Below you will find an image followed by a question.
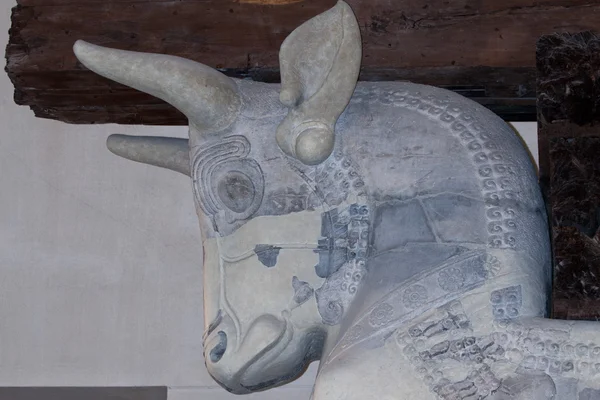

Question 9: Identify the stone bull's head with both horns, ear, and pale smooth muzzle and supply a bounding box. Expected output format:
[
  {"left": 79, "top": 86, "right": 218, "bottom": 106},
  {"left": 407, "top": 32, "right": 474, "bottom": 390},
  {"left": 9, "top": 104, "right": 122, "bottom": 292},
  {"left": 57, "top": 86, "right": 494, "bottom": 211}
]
[{"left": 74, "top": 1, "right": 361, "bottom": 393}]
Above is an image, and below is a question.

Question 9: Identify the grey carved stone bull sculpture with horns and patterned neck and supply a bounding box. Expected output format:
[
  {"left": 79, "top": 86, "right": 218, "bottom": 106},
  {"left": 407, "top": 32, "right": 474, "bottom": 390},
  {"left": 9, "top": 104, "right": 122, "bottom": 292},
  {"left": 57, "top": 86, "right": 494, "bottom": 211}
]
[{"left": 74, "top": 2, "right": 600, "bottom": 400}]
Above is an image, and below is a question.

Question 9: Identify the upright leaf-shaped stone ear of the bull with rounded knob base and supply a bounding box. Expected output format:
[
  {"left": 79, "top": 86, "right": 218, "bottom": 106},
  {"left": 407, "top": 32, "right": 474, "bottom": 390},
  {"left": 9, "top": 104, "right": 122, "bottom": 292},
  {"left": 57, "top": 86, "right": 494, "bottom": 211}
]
[{"left": 277, "top": 1, "right": 362, "bottom": 165}]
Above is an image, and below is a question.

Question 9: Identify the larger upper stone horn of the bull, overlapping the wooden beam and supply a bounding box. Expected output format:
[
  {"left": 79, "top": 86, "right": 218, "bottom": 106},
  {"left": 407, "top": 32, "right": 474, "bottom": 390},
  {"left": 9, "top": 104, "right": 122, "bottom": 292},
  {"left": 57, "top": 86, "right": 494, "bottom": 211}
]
[{"left": 73, "top": 40, "right": 242, "bottom": 133}]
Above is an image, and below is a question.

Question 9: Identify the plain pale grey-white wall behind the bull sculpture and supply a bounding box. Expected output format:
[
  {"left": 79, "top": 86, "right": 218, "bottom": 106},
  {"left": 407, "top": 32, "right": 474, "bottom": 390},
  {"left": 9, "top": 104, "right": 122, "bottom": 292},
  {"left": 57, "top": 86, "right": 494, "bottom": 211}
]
[{"left": 0, "top": 0, "right": 537, "bottom": 400}]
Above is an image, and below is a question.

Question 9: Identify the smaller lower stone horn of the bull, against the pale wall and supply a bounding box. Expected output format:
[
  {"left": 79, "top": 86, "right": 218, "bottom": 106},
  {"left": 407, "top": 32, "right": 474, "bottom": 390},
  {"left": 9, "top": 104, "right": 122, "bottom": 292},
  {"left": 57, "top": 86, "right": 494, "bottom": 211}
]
[{"left": 106, "top": 135, "right": 190, "bottom": 176}]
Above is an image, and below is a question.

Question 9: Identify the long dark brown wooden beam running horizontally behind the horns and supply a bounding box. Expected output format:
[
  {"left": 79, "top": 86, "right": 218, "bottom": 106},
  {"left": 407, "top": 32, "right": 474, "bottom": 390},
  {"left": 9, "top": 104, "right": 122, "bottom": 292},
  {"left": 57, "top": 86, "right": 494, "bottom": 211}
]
[{"left": 6, "top": 0, "right": 600, "bottom": 125}]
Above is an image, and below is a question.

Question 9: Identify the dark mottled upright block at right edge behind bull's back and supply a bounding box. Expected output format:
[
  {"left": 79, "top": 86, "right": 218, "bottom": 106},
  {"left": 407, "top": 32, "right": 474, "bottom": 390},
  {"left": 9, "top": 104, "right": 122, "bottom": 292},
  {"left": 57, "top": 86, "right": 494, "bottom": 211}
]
[{"left": 537, "top": 32, "right": 600, "bottom": 320}]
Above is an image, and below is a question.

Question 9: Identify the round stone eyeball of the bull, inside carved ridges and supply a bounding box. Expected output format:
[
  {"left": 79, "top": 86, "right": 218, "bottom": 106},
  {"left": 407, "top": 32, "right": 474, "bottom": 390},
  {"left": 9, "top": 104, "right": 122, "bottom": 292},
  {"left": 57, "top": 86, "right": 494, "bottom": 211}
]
[{"left": 217, "top": 171, "right": 256, "bottom": 213}]
